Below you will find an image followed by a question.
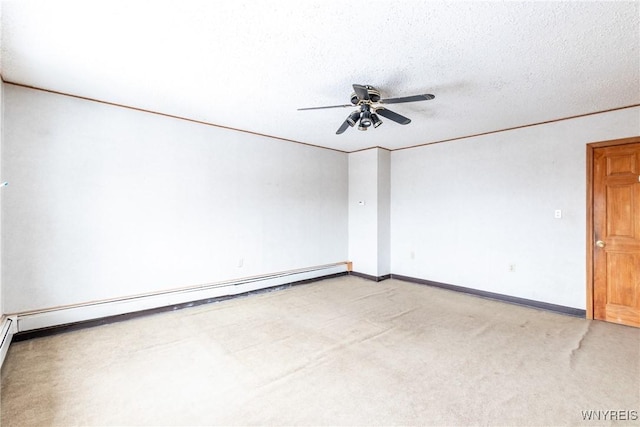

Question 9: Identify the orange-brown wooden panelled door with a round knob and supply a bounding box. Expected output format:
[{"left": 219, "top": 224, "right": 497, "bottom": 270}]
[{"left": 589, "top": 138, "right": 640, "bottom": 327}]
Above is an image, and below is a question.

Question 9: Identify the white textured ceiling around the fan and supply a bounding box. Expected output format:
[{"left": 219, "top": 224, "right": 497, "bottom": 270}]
[{"left": 0, "top": 0, "right": 640, "bottom": 151}]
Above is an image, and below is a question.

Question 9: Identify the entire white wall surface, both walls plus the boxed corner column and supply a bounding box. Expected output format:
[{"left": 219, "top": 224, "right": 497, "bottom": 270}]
[{"left": 5, "top": 84, "right": 640, "bottom": 313}]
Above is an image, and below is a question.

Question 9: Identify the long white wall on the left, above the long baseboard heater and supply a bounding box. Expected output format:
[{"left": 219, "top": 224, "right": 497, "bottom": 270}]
[{"left": 2, "top": 85, "right": 348, "bottom": 312}]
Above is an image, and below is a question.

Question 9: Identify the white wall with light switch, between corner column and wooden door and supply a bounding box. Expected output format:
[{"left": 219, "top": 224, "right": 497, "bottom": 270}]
[{"left": 391, "top": 108, "right": 640, "bottom": 308}]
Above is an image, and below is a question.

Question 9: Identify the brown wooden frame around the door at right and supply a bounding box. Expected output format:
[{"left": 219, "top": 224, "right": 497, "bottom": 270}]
[{"left": 586, "top": 136, "right": 640, "bottom": 319}]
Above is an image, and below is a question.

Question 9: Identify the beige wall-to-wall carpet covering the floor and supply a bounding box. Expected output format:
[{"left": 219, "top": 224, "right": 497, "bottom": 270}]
[{"left": 1, "top": 276, "right": 640, "bottom": 427}]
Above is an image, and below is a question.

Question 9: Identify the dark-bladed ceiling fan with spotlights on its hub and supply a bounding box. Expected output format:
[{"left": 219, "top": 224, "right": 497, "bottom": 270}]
[{"left": 298, "top": 84, "right": 435, "bottom": 134}]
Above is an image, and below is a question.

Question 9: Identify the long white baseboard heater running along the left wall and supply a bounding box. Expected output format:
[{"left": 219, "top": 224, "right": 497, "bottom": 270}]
[{"left": 13, "top": 262, "right": 348, "bottom": 334}]
